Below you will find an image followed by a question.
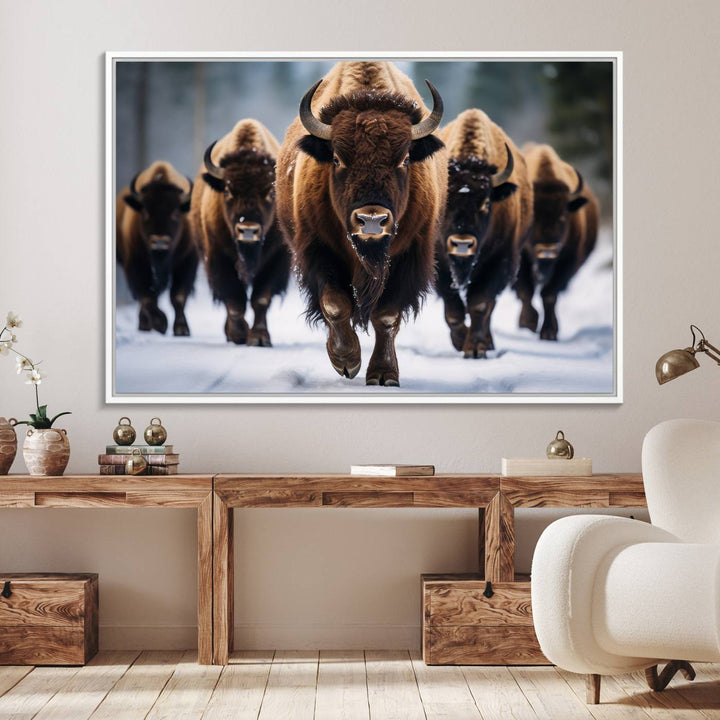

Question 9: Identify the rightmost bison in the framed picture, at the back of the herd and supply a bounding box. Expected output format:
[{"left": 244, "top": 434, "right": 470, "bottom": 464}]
[{"left": 515, "top": 145, "right": 599, "bottom": 340}]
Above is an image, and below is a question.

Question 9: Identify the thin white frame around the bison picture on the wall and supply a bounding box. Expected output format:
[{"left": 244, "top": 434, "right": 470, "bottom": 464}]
[{"left": 105, "top": 51, "right": 623, "bottom": 404}]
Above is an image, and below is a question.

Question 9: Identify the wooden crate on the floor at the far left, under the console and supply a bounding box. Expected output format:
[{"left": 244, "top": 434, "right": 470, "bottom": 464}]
[{"left": 0, "top": 573, "right": 98, "bottom": 665}]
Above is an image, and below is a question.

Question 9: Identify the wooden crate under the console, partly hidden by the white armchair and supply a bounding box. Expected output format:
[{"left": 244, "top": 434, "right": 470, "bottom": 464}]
[{"left": 422, "top": 574, "right": 550, "bottom": 665}]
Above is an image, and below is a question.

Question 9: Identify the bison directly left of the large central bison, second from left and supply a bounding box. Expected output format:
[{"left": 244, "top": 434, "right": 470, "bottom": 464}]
[{"left": 190, "top": 120, "right": 290, "bottom": 347}]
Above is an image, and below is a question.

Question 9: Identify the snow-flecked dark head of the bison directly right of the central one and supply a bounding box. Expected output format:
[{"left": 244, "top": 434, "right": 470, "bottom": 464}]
[{"left": 442, "top": 144, "right": 517, "bottom": 287}]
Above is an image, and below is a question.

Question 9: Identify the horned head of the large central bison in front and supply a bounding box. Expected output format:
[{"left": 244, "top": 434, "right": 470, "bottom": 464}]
[{"left": 299, "top": 81, "right": 443, "bottom": 278}]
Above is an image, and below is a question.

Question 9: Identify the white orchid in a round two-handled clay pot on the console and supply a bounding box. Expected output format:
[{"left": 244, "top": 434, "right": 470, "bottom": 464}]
[{"left": 0, "top": 312, "right": 70, "bottom": 475}]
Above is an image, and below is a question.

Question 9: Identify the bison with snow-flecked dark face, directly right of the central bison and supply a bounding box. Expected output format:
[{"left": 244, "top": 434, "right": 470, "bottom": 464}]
[{"left": 436, "top": 109, "right": 532, "bottom": 358}]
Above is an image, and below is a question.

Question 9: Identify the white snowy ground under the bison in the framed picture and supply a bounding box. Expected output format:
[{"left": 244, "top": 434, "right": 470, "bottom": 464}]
[{"left": 115, "top": 229, "right": 614, "bottom": 399}]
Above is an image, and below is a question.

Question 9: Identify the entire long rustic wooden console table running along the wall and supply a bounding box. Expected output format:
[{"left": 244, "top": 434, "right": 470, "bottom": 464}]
[{"left": 0, "top": 474, "right": 645, "bottom": 665}]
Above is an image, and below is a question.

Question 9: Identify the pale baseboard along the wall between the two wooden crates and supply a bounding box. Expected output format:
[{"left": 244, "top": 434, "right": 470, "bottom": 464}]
[{"left": 100, "top": 623, "right": 420, "bottom": 650}]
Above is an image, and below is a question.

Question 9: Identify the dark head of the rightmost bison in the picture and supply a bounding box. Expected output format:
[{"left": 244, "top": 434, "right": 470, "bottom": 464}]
[{"left": 529, "top": 170, "right": 587, "bottom": 285}]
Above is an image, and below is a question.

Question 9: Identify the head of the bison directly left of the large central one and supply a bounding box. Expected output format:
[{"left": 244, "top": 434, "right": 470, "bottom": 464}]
[{"left": 203, "top": 143, "right": 275, "bottom": 276}]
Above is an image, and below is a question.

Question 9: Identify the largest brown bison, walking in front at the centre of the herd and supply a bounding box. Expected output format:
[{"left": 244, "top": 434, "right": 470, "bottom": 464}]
[{"left": 277, "top": 62, "right": 447, "bottom": 386}]
